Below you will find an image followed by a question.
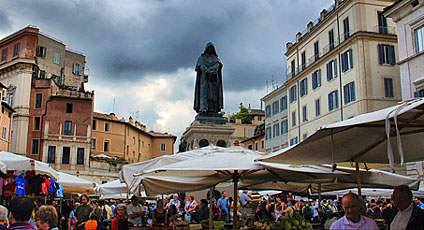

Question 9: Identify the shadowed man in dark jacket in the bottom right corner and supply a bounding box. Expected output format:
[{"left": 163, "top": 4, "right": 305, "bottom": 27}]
[{"left": 390, "top": 185, "right": 424, "bottom": 230}]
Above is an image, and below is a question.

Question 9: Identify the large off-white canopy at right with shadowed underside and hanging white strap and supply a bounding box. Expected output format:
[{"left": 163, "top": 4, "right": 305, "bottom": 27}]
[{"left": 260, "top": 98, "right": 424, "bottom": 172}]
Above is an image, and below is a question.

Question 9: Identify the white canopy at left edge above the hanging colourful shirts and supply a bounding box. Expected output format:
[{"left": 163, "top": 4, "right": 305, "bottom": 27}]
[{"left": 0, "top": 151, "right": 59, "bottom": 180}]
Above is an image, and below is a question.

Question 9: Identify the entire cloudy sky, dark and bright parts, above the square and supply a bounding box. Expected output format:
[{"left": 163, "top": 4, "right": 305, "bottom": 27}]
[{"left": 0, "top": 0, "right": 333, "bottom": 145}]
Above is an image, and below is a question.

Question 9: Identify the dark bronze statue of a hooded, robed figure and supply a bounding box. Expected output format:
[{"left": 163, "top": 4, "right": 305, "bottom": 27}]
[{"left": 194, "top": 42, "right": 224, "bottom": 115}]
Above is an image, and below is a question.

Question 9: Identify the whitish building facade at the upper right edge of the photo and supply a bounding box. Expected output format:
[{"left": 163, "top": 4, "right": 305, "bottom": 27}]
[{"left": 383, "top": 0, "right": 424, "bottom": 100}]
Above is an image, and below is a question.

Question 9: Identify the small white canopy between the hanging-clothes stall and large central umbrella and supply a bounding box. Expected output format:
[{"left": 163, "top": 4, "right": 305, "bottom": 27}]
[{"left": 58, "top": 172, "right": 96, "bottom": 193}]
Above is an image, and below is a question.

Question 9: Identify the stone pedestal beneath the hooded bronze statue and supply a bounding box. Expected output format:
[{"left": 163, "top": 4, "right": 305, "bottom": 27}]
[{"left": 180, "top": 119, "right": 234, "bottom": 151}]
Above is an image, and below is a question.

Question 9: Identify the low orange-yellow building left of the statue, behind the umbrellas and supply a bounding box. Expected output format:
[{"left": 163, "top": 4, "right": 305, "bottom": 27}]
[{"left": 91, "top": 112, "right": 177, "bottom": 163}]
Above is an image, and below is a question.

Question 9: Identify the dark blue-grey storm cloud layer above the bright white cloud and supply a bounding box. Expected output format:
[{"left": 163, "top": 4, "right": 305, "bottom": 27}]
[{"left": 0, "top": 0, "right": 332, "bottom": 90}]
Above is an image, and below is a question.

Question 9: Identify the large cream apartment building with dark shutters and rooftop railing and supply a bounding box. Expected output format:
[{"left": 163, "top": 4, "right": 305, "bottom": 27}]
[{"left": 284, "top": 0, "right": 401, "bottom": 148}]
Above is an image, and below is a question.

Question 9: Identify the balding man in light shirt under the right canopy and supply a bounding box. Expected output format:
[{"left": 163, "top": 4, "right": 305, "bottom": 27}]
[{"left": 330, "top": 192, "right": 378, "bottom": 230}]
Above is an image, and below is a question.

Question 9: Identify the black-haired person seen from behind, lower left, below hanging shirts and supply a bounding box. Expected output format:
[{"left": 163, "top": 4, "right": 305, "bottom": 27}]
[{"left": 9, "top": 196, "right": 35, "bottom": 230}]
